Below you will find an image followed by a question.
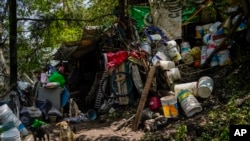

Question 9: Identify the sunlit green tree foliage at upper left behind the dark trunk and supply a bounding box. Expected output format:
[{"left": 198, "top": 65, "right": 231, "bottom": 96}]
[{"left": 0, "top": 0, "right": 118, "bottom": 73}]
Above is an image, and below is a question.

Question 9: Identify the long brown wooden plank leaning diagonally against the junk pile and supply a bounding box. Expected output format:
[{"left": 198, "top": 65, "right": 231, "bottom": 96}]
[{"left": 133, "top": 66, "right": 156, "bottom": 131}]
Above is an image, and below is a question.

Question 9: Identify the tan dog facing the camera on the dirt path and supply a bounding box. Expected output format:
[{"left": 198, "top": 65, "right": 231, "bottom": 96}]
[{"left": 56, "top": 121, "right": 76, "bottom": 141}]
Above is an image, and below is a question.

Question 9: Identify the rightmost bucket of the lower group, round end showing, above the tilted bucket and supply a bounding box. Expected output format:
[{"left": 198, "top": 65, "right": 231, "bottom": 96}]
[{"left": 198, "top": 76, "right": 214, "bottom": 98}]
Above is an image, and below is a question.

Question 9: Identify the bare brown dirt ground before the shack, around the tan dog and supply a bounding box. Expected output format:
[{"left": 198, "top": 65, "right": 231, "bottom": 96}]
[{"left": 24, "top": 120, "right": 144, "bottom": 141}]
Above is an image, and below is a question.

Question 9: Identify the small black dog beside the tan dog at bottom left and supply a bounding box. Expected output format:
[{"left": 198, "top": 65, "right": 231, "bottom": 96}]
[{"left": 30, "top": 124, "right": 50, "bottom": 141}]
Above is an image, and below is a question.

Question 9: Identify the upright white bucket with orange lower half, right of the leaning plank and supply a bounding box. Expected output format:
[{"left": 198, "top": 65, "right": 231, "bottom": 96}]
[{"left": 160, "top": 95, "right": 179, "bottom": 118}]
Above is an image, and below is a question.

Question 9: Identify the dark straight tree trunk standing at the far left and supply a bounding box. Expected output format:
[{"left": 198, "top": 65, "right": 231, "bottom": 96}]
[{"left": 9, "top": 0, "right": 17, "bottom": 85}]
